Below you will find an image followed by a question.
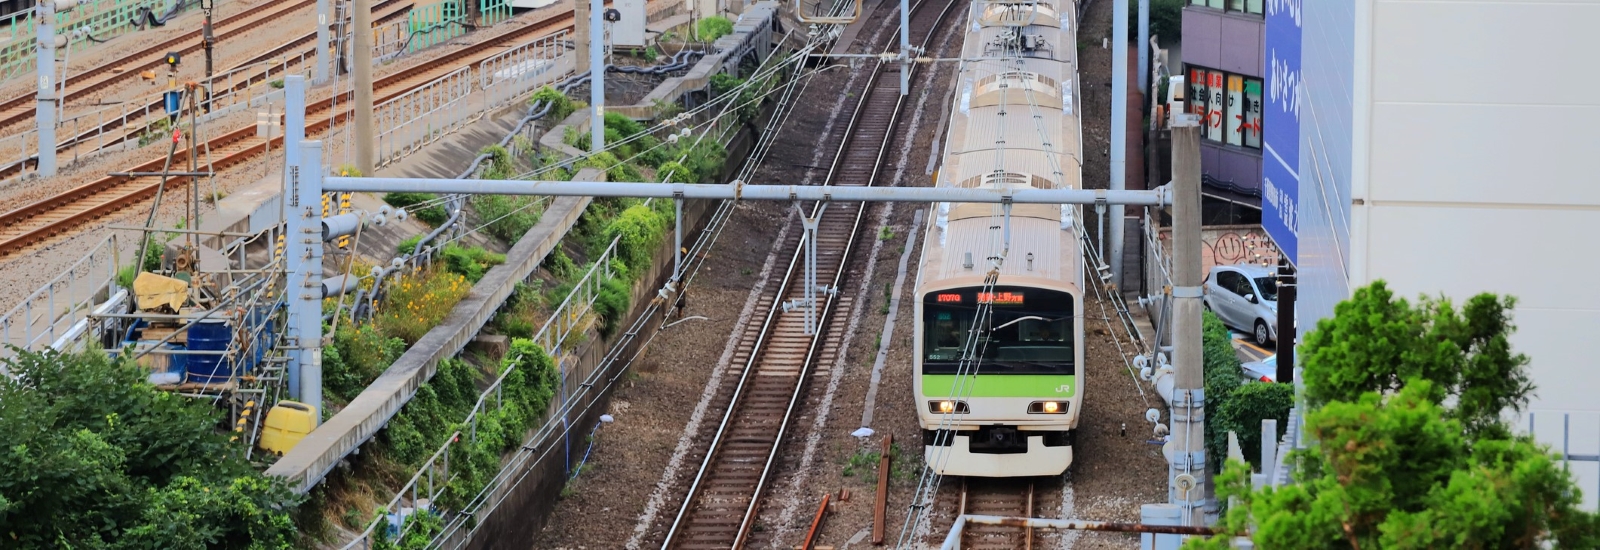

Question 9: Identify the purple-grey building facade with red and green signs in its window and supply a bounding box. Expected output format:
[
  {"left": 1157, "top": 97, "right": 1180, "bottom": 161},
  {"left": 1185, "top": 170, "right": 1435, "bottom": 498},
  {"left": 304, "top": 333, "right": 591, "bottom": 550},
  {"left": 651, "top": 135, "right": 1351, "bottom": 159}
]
[{"left": 1182, "top": 0, "right": 1264, "bottom": 197}]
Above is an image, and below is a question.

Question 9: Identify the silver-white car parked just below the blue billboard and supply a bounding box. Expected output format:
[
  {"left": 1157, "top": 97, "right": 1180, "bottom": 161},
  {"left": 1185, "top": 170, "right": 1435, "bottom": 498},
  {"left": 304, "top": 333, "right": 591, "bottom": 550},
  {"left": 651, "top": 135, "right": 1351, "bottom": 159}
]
[{"left": 1205, "top": 264, "right": 1278, "bottom": 345}]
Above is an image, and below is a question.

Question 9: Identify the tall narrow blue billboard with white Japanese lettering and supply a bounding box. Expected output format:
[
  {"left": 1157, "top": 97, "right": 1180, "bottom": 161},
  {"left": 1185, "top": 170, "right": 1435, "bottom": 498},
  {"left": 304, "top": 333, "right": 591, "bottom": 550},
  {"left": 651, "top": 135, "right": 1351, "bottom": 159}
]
[{"left": 1261, "top": 0, "right": 1301, "bottom": 264}]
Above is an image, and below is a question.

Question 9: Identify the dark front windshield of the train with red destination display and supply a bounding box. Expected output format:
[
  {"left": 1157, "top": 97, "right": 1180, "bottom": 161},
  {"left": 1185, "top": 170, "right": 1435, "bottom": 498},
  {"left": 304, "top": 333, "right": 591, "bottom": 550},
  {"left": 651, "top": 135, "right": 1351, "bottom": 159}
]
[{"left": 922, "top": 286, "right": 1077, "bottom": 374}]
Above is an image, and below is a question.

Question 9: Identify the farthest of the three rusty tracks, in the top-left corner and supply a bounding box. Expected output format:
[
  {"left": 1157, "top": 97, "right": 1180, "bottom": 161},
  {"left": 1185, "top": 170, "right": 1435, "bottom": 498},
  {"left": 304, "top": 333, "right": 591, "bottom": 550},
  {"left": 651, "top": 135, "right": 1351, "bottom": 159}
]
[{"left": 0, "top": 0, "right": 315, "bottom": 131}]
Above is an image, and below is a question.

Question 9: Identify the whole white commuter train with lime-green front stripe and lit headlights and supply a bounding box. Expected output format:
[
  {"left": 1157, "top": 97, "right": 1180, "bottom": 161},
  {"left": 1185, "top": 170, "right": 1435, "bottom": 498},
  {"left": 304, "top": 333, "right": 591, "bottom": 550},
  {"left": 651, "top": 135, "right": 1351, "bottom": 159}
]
[{"left": 914, "top": 0, "right": 1083, "bottom": 476}]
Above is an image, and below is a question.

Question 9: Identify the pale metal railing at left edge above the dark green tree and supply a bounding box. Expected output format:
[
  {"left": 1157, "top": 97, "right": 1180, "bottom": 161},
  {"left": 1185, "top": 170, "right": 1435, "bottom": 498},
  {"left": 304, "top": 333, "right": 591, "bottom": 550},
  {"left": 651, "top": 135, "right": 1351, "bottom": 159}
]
[{"left": 0, "top": 235, "right": 120, "bottom": 360}]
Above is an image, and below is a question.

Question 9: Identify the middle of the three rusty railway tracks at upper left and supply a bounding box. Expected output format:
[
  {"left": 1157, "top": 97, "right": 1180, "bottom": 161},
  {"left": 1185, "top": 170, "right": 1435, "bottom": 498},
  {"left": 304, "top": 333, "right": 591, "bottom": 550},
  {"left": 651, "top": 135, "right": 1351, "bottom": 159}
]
[{"left": 0, "top": 0, "right": 413, "bottom": 181}]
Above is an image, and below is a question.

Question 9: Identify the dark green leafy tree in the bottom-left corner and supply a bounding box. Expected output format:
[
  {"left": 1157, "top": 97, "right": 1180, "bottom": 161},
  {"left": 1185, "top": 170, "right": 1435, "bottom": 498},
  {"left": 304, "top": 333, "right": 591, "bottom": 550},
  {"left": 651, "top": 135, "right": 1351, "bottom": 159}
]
[{"left": 0, "top": 352, "right": 299, "bottom": 548}]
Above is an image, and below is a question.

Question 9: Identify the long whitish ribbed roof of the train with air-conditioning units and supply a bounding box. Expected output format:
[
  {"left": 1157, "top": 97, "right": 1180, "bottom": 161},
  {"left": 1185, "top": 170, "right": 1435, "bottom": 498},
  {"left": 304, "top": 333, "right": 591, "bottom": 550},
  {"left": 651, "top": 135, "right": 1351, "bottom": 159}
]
[{"left": 918, "top": 0, "right": 1083, "bottom": 293}]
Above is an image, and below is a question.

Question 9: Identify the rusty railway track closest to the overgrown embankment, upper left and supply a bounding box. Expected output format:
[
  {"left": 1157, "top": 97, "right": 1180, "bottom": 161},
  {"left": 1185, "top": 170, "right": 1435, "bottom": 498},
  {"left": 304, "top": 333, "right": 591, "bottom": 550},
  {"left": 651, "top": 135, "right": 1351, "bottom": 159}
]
[{"left": 0, "top": 13, "right": 573, "bottom": 257}]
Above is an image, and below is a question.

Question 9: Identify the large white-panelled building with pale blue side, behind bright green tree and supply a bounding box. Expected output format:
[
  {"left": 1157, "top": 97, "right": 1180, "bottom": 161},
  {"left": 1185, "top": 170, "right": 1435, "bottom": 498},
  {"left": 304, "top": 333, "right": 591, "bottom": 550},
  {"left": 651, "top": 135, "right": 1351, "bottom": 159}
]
[{"left": 1286, "top": 0, "right": 1600, "bottom": 508}]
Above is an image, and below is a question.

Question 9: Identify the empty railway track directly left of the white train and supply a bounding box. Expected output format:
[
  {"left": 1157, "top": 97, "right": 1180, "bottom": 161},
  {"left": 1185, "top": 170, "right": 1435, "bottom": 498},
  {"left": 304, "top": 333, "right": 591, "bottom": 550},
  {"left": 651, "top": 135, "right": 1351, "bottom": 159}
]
[{"left": 662, "top": 0, "right": 958, "bottom": 548}]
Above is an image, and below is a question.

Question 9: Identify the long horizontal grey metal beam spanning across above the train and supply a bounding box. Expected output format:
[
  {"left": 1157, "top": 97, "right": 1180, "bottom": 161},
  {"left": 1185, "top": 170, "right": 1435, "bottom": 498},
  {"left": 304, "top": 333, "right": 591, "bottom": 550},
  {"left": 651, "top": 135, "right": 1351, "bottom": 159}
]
[{"left": 322, "top": 177, "right": 1171, "bottom": 206}]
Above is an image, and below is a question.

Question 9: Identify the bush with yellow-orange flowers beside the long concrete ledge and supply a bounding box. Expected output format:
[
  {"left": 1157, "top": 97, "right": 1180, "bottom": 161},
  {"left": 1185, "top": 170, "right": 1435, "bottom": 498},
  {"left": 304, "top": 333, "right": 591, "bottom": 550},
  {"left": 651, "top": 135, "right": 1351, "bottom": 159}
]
[{"left": 373, "top": 269, "right": 472, "bottom": 344}]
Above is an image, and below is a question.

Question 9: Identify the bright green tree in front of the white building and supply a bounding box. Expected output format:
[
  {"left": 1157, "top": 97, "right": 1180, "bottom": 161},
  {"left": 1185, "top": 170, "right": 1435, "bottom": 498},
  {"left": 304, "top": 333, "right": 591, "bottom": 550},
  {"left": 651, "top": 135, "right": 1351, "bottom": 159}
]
[{"left": 1189, "top": 281, "right": 1600, "bottom": 550}]
